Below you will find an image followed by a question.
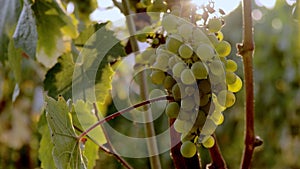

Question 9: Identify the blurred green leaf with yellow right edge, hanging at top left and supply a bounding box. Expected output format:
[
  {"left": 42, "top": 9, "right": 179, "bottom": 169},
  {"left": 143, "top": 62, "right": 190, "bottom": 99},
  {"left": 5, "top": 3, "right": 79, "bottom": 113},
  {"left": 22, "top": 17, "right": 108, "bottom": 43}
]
[{"left": 32, "top": 0, "right": 78, "bottom": 67}]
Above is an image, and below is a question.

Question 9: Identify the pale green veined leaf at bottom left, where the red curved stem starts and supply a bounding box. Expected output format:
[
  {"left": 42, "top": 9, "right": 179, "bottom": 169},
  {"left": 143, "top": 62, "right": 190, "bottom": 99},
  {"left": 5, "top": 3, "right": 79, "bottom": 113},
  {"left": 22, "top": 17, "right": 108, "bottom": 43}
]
[{"left": 45, "top": 96, "right": 86, "bottom": 169}]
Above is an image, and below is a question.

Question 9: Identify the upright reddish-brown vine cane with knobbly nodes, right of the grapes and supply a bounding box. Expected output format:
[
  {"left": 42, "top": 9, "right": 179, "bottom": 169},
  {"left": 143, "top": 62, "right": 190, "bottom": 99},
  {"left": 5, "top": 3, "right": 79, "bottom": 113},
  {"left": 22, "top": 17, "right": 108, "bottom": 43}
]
[{"left": 237, "top": 0, "right": 255, "bottom": 169}]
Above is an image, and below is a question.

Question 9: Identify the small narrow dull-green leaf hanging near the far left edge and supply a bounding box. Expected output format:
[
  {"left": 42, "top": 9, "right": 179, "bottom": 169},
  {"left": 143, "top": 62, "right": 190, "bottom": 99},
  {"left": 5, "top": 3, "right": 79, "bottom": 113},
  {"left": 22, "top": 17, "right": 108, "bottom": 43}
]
[{"left": 8, "top": 40, "right": 22, "bottom": 83}]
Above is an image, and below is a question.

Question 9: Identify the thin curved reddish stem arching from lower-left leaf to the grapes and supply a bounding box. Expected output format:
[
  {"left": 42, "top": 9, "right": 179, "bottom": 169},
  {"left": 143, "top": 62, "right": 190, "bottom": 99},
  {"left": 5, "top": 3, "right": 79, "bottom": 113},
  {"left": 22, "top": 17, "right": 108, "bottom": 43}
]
[{"left": 77, "top": 96, "right": 174, "bottom": 140}]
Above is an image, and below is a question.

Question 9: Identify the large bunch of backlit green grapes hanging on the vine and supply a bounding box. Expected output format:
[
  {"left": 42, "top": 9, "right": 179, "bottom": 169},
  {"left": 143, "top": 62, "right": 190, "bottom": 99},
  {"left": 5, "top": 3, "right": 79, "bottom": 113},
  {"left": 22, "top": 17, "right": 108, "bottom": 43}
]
[{"left": 136, "top": 0, "right": 242, "bottom": 158}]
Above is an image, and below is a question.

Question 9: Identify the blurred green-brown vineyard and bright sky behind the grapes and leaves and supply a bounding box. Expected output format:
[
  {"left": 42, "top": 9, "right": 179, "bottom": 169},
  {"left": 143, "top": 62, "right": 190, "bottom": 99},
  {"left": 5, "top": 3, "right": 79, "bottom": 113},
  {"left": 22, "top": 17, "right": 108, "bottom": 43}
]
[{"left": 0, "top": 0, "right": 300, "bottom": 169}]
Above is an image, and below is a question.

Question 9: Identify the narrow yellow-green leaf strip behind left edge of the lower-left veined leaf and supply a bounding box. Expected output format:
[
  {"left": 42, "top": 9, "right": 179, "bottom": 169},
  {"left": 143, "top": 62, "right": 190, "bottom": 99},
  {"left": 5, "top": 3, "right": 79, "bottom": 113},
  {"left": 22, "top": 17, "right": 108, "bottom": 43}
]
[{"left": 38, "top": 113, "right": 56, "bottom": 169}]
